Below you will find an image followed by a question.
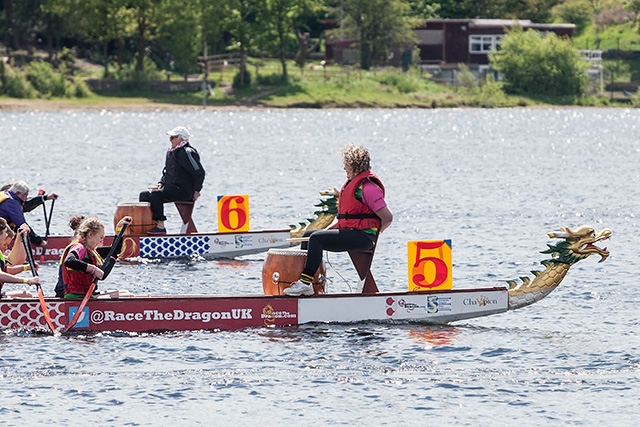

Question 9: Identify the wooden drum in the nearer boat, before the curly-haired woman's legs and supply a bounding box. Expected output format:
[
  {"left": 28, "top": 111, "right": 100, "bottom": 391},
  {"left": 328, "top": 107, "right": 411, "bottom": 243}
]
[{"left": 262, "top": 249, "right": 326, "bottom": 295}]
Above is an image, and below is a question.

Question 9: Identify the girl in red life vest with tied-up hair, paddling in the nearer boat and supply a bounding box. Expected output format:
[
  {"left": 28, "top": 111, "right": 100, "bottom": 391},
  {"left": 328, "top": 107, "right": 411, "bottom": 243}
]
[{"left": 56, "top": 216, "right": 131, "bottom": 299}]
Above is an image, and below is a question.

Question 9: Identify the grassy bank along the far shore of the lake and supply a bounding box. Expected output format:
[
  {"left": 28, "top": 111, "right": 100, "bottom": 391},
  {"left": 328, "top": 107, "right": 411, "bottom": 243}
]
[{"left": 0, "top": 61, "right": 633, "bottom": 110}]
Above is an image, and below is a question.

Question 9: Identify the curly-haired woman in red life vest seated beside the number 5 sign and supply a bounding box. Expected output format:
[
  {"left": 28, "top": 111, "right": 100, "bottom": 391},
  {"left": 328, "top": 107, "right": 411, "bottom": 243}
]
[{"left": 283, "top": 143, "right": 393, "bottom": 296}]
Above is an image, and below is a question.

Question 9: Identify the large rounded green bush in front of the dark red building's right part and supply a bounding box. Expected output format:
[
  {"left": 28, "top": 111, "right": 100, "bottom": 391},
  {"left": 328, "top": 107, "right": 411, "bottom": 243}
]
[{"left": 489, "top": 27, "right": 589, "bottom": 97}]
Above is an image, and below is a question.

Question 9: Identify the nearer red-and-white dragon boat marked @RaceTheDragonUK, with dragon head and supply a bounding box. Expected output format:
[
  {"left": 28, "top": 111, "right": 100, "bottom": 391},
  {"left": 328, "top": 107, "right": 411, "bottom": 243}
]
[{"left": 0, "top": 226, "right": 611, "bottom": 332}]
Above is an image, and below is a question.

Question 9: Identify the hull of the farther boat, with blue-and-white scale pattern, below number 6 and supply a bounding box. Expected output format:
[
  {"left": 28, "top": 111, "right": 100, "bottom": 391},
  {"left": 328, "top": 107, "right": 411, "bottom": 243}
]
[{"left": 34, "top": 230, "right": 291, "bottom": 261}]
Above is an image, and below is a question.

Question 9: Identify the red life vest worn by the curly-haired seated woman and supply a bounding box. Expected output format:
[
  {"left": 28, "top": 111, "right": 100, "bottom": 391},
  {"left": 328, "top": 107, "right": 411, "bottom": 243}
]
[{"left": 338, "top": 170, "right": 384, "bottom": 230}]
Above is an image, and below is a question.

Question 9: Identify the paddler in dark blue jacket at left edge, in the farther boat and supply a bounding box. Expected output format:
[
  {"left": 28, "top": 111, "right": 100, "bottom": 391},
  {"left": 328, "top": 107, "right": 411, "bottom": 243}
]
[{"left": 0, "top": 181, "right": 58, "bottom": 247}]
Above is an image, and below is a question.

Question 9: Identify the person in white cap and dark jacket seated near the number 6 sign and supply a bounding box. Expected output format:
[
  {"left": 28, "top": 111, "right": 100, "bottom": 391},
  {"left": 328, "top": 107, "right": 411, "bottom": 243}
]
[{"left": 139, "top": 126, "right": 205, "bottom": 235}]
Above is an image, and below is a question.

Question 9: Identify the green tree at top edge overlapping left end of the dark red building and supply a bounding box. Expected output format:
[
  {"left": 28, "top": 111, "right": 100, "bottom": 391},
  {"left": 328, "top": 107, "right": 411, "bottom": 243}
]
[{"left": 343, "top": 0, "right": 416, "bottom": 70}]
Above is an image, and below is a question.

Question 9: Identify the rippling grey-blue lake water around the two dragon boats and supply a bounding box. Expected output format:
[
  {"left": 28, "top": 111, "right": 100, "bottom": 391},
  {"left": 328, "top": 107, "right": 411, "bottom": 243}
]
[{"left": 0, "top": 108, "right": 640, "bottom": 426}]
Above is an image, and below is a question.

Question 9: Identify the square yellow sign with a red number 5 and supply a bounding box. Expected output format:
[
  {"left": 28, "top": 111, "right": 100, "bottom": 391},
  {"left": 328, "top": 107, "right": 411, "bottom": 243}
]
[{"left": 407, "top": 240, "right": 453, "bottom": 292}]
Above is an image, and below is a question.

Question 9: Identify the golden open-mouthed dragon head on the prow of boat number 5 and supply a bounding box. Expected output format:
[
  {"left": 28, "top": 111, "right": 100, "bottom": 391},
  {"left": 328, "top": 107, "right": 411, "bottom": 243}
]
[{"left": 541, "top": 225, "right": 611, "bottom": 264}]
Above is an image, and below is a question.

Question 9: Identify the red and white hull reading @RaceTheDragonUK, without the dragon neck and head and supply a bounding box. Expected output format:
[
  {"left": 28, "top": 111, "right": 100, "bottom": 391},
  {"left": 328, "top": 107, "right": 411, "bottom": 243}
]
[{"left": 0, "top": 287, "right": 509, "bottom": 332}]
